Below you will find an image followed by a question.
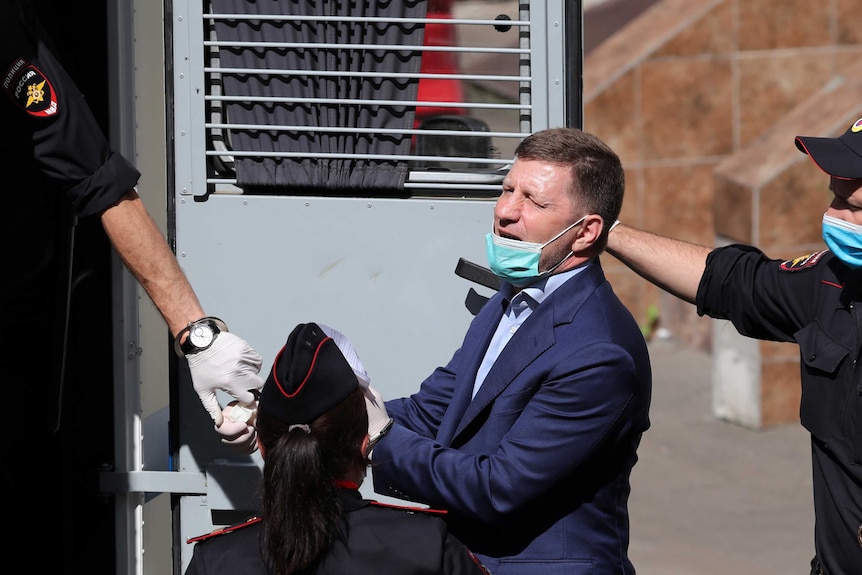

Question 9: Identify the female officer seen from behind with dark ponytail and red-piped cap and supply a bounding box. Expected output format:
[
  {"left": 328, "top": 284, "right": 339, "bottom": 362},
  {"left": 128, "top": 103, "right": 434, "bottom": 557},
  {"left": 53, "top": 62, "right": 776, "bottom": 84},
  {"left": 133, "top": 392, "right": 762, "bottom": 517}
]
[{"left": 186, "top": 323, "right": 488, "bottom": 575}]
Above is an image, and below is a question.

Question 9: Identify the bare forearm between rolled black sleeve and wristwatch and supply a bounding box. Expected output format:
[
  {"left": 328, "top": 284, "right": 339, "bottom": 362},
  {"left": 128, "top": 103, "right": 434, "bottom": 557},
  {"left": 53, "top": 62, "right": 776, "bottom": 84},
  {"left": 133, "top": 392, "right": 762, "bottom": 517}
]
[{"left": 102, "top": 191, "right": 205, "bottom": 335}]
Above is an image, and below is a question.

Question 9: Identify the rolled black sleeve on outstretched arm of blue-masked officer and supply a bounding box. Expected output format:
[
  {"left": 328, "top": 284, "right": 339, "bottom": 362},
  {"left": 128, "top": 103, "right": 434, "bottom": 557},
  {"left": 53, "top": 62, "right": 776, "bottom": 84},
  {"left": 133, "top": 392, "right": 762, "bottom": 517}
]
[{"left": 695, "top": 245, "right": 825, "bottom": 342}]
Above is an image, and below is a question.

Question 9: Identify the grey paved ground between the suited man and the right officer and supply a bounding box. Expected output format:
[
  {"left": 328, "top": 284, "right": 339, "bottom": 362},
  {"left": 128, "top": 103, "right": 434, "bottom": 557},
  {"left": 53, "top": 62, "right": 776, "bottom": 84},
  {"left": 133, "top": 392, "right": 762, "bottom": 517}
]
[{"left": 630, "top": 341, "right": 814, "bottom": 575}]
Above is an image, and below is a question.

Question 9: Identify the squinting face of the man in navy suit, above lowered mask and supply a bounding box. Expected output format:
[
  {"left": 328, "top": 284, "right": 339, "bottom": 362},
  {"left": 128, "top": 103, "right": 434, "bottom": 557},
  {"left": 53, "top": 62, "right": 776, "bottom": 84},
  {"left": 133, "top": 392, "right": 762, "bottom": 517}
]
[{"left": 494, "top": 159, "right": 580, "bottom": 271}]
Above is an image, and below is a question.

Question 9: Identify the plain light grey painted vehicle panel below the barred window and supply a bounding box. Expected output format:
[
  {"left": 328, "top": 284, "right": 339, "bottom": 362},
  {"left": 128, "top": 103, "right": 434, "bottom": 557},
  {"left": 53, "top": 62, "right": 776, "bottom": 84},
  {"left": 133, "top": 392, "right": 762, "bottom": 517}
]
[{"left": 176, "top": 195, "right": 494, "bottom": 568}]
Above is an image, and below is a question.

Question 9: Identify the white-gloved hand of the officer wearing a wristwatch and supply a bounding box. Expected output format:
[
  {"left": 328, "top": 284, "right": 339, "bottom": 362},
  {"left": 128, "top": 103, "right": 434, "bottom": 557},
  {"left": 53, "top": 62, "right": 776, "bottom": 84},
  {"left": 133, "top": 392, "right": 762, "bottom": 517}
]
[{"left": 186, "top": 331, "right": 264, "bottom": 428}]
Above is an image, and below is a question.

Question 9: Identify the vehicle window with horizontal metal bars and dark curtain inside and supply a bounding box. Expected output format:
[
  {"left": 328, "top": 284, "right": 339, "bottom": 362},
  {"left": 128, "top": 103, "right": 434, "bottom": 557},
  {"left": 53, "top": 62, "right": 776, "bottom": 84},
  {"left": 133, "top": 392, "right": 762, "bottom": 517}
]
[{"left": 174, "top": 0, "right": 580, "bottom": 198}]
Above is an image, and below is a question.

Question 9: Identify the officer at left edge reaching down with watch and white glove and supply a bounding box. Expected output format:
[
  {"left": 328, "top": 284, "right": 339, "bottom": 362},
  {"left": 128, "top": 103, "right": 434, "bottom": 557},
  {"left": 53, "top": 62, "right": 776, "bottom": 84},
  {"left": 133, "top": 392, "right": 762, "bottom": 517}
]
[{"left": 0, "top": 0, "right": 263, "bottom": 573}]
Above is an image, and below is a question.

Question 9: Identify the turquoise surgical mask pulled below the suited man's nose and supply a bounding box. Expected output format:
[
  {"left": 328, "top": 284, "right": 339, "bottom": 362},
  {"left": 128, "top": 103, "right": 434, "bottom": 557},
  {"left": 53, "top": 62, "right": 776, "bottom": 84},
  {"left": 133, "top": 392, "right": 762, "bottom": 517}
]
[{"left": 485, "top": 216, "right": 587, "bottom": 287}]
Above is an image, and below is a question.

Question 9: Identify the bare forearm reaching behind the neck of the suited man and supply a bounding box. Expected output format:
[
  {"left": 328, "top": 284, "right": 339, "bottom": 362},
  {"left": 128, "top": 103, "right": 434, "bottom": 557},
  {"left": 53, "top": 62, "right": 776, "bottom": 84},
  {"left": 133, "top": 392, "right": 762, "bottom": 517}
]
[{"left": 607, "top": 224, "right": 712, "bottom": 303}]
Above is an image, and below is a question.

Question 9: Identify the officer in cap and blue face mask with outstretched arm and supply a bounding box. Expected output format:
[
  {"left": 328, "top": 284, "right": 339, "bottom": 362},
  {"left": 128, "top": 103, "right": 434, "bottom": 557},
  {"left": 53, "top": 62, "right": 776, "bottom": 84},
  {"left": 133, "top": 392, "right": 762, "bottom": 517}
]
[{"left": 608, "top": 118, "right": 862, "bottom": 575}]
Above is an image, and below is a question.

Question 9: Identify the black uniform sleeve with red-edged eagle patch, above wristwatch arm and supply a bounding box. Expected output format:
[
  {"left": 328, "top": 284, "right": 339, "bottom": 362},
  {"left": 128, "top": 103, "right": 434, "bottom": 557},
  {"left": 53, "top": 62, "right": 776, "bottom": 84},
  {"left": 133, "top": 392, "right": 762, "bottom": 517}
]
[{"left": 0, "top": 1, "right": 140, "bottom": 216}]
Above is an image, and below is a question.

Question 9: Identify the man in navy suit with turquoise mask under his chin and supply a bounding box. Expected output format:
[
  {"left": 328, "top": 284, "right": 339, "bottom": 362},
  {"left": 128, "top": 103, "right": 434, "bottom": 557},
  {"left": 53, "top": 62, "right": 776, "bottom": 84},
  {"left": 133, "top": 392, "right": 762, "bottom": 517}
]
[{"left": 367, "top": 128, "right": 652, "bottom": 575}]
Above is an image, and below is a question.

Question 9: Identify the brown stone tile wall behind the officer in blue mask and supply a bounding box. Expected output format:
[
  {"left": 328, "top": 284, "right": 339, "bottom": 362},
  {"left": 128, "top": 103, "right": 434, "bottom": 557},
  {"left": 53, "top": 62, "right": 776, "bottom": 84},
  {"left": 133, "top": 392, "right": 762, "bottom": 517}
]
[{"left": 584, "top": 0, "right": 862, "bottom": 427}]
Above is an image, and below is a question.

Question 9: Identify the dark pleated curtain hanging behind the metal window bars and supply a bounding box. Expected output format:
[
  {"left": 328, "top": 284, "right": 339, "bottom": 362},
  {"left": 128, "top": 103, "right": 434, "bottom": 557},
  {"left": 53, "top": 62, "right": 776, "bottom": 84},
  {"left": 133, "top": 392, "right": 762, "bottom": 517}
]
[{"left": 212, "top": 0, "right": 426, "bottom": 195}]
